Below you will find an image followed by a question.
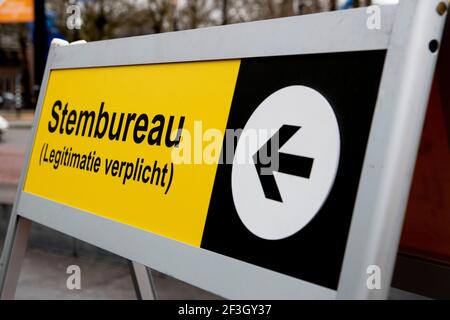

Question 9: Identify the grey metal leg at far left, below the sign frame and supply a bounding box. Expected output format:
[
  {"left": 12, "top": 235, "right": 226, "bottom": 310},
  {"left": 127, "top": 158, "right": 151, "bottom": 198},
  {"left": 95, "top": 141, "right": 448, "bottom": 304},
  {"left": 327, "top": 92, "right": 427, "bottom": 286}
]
[{"left": 0, "top": 212, "right": 31, "bottom": 300}]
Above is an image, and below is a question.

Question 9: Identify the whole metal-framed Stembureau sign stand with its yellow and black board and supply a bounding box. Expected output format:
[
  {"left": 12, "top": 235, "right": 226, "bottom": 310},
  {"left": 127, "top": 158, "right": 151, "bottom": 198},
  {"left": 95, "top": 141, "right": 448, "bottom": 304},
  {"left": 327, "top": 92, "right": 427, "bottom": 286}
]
[{"left": 0, "top": 0, "right": 447, "bottom": 299}]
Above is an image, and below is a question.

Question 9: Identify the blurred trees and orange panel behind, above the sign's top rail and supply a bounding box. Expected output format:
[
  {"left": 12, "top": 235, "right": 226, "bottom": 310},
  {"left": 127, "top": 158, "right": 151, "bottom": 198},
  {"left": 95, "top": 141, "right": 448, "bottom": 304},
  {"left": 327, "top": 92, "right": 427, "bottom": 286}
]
[{"left": 0, "top": 0, "right": 397, "bottom": 111}]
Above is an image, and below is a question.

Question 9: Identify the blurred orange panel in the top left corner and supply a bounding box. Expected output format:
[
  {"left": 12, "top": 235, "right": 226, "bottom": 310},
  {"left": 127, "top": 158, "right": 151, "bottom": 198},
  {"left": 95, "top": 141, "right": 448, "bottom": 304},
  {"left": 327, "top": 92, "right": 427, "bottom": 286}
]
[{"left": 0, "top": 0, "right": 34, "bottom": 23}]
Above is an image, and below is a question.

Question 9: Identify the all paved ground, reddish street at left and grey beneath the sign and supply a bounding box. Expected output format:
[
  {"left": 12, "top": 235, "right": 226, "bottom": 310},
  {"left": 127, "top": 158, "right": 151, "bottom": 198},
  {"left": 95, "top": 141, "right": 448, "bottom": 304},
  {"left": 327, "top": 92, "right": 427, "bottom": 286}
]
[{"left": 0, "top": 113, "right": 218, "bottom": 299}]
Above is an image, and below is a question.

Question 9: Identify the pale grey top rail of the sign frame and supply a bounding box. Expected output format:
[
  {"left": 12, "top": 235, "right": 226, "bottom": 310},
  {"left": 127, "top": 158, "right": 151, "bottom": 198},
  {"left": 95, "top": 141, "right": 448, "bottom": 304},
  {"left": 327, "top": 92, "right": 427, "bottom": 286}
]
[{"left": 51, "top": 6, "right": 397, "bottom": 69}]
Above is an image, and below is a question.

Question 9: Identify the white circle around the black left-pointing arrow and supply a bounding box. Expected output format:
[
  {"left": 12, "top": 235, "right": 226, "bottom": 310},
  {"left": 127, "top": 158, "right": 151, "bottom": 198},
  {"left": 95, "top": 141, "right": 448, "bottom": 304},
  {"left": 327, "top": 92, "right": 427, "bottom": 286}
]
[{"left": 231, "top": 86, "right": 340, "bottom": 240}]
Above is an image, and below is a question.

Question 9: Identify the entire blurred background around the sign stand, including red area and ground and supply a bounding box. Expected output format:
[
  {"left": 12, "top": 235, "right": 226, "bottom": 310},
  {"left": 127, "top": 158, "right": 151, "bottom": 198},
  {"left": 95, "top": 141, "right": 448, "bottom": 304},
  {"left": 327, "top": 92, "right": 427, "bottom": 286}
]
[{"left": 0, "top": 0, "right": 450, "bottom": 299}]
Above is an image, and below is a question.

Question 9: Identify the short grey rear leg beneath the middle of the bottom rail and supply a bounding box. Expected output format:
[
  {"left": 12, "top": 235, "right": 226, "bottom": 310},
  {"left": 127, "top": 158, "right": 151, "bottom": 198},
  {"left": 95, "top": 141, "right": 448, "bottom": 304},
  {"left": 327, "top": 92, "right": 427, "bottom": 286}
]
[{"left": 128, "top": 260, "right": 157, "bottom": 300}]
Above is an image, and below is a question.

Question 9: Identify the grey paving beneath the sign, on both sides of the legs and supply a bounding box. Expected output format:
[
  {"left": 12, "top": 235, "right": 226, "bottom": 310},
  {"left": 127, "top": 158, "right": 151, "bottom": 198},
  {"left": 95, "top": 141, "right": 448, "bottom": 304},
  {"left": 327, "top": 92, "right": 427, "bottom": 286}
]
[{"left": 0, "top": 205, "right": 219, "bottom": 300}]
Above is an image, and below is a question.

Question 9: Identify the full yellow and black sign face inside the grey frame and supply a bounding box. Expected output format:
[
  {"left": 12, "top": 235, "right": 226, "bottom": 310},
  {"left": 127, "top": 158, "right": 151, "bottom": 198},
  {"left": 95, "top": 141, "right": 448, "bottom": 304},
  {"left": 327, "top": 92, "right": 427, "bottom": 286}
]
[{"left": 24, "top": 51, "right": 385, "bottom": 289}]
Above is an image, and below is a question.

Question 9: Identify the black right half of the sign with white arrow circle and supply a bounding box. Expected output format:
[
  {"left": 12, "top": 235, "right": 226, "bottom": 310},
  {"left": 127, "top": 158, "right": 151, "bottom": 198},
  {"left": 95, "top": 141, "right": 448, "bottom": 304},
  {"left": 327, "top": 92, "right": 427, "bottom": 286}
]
[{"left": 202, "top": 51, "right": 385, "bottom": 289}]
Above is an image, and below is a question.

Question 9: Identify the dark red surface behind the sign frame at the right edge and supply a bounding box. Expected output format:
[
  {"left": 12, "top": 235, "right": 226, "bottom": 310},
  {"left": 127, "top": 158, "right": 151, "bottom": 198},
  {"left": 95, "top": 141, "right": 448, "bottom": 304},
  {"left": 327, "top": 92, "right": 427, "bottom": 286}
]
[{"left": 400, "top": 19, "right": 450, "bottom": 264}]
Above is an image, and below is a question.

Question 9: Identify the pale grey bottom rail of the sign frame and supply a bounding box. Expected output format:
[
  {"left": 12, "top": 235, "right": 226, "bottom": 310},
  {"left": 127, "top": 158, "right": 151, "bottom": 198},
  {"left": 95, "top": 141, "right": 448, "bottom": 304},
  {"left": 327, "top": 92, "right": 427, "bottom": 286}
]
[{"left": 18, "top": 192, "right": 336, "bottom": 299}]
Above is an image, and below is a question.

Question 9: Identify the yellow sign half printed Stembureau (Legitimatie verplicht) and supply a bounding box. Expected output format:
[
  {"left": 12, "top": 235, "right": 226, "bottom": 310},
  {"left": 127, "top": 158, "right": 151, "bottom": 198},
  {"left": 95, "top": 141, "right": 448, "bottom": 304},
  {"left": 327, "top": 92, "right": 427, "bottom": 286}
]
[{"left": 24, "top": 60, "right": 240, "bottom": 247}]
